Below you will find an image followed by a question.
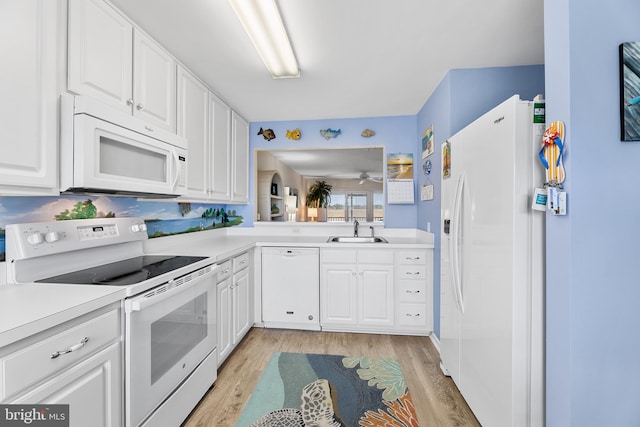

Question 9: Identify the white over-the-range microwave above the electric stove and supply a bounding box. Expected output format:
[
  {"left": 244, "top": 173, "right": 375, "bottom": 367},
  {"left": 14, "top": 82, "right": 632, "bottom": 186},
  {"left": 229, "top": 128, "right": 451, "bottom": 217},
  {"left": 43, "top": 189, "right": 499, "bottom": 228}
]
[{"left": 60, "top": 95, "right": 187, "bottom": 197}]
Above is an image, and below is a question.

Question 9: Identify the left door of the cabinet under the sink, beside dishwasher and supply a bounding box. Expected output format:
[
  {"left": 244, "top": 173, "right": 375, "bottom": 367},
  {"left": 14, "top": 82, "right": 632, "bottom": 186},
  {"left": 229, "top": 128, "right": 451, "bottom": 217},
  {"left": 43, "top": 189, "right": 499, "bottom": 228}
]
[{"left": 320, "top": 263, "right": 357, "bottom": 325}]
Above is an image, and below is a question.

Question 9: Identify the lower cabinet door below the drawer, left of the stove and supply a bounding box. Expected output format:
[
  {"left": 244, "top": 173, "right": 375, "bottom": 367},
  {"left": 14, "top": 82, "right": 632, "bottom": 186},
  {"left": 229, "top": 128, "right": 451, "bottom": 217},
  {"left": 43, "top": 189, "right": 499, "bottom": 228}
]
[{"left": 7, "top": 342, "right": 123, "bottom": 427}]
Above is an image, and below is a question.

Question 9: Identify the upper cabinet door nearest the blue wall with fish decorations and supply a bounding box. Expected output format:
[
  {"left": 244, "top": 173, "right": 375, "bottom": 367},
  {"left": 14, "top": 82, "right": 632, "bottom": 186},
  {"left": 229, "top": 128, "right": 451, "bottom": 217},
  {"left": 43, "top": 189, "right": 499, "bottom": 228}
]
[{"left": 231, "top": 112, "right": 249, "bottom": 202}]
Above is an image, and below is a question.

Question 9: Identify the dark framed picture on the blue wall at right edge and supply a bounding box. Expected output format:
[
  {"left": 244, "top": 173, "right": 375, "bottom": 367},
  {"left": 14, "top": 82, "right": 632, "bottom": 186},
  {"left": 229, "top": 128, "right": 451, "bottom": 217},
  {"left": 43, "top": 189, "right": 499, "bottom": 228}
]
[{"left": 620, "top": 42, "right": 640, "bottom": 141}]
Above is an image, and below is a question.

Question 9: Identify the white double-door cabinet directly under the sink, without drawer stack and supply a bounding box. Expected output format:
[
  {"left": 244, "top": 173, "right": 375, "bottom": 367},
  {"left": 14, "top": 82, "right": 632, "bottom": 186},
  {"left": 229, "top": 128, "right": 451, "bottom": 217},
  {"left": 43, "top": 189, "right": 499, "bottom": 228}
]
[{"left": 320, "top": 248, "right": 395, "bottom": 332}]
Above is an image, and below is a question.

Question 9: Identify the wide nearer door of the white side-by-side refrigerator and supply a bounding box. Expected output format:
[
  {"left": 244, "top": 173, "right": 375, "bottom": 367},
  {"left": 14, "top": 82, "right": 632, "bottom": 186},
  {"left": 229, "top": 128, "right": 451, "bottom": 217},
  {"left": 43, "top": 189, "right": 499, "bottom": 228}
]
[{"left": 460, "top": 97, "right": 516, "bottom": 426}]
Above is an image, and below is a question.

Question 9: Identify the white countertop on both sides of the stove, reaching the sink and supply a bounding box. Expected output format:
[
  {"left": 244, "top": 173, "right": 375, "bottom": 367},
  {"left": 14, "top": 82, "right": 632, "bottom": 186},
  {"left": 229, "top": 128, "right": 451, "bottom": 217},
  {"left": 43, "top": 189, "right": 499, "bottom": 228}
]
[{"left": 0, "top": 223, "right": 433, "bottom": 348}]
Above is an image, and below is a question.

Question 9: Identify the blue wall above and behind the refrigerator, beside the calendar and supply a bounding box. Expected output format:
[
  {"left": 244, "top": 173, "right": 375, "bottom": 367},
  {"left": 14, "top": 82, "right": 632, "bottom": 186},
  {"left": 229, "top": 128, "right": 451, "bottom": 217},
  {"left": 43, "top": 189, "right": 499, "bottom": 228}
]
[{"left": 416, "top": 65, "right": 544, "bottom": 342}]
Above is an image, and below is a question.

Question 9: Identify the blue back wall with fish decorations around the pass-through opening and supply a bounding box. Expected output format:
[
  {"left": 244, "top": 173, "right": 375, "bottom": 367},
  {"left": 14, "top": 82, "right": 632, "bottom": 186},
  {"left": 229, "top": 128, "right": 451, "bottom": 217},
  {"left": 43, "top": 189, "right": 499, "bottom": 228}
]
[{"left": 238, "top": 116, "right": 420, "bottom": 228}]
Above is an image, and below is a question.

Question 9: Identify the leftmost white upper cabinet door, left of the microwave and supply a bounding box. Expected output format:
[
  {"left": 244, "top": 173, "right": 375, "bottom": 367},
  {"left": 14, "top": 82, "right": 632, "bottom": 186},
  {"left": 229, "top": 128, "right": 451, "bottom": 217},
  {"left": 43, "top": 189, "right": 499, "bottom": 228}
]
[{"left": 0, "top": 0, "right": 61, "bottom": 195}]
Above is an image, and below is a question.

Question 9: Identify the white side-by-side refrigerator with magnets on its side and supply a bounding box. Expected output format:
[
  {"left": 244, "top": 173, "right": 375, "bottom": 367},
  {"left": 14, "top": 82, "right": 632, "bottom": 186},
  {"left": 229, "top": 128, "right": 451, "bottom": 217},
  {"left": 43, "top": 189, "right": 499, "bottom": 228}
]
[{"left": 440, "top": 95, "right": 545, "bottom": 427}]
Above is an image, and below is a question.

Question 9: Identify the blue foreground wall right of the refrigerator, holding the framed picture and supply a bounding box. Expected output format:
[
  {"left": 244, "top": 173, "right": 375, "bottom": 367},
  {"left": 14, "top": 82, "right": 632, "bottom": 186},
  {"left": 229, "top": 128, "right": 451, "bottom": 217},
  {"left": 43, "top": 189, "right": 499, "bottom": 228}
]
[{"left": 544, "top": 0, "right": 640, "bottom": 427}]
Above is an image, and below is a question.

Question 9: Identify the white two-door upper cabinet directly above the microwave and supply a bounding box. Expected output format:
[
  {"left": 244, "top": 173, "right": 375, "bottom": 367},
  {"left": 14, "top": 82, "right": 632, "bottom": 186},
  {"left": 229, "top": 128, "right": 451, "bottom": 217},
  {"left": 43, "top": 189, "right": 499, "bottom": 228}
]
[{"left": 67, "top": 0, "right": 176, "bottom": 132}]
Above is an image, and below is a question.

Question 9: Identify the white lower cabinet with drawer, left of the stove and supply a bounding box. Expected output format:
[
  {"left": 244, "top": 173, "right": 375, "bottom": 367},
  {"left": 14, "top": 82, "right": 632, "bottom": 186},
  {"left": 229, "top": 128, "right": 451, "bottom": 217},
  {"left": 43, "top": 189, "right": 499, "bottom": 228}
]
[{"left": 0, "top": 303, "right": 123, "bottom": 427}]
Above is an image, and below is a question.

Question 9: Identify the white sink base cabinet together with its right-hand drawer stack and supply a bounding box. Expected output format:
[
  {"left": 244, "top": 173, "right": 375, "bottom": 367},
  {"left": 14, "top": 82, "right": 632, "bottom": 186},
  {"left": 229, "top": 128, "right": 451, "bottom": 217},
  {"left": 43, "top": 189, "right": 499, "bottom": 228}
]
[{"left": 320, "top": 247, "right": 433, "bottom": 335}]
